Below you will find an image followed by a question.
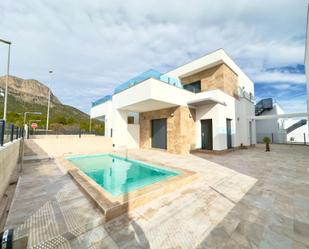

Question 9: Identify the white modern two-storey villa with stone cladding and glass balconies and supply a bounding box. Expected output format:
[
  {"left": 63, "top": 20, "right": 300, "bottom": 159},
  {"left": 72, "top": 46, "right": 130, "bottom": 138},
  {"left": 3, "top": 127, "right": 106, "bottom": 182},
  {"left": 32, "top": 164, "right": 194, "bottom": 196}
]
[{"left": 91, "top": 49, "right": 256, "bottom": 154}]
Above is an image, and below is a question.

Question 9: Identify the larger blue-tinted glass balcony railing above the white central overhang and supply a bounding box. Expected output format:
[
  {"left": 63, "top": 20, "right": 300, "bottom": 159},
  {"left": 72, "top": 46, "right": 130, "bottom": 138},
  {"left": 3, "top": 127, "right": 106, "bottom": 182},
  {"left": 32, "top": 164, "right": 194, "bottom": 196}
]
[{"left": 114, "top": 69, "right": 183, "bottom": 94}]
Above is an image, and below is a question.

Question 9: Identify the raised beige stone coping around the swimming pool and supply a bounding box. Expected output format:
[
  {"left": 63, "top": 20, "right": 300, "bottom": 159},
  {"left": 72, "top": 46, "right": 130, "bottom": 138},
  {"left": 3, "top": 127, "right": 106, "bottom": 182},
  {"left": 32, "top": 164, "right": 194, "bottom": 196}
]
[{"left": 58, "top": 153, "right": 200, "bottom": 221}]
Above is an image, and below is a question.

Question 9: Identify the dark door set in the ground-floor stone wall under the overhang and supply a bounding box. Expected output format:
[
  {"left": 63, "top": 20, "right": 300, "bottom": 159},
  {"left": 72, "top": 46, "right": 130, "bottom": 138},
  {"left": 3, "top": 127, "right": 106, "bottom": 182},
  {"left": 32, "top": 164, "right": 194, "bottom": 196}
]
[{"left": 151, "top": 118, "right": 167, "bottom": 149}]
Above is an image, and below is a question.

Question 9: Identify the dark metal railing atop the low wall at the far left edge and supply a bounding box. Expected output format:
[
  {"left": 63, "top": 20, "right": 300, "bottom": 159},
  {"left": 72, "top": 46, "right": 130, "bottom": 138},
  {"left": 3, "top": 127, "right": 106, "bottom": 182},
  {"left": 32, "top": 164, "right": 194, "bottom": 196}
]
[{"left": 0, "top": 120, "right": 24, "bottom": 146}]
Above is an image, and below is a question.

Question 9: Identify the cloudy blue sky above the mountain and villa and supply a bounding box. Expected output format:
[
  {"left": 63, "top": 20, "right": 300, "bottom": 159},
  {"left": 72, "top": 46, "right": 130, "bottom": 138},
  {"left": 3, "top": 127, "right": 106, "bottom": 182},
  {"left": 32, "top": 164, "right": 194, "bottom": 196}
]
[{"left": 0, "top": 0, "right": 308, "bottom": 112}]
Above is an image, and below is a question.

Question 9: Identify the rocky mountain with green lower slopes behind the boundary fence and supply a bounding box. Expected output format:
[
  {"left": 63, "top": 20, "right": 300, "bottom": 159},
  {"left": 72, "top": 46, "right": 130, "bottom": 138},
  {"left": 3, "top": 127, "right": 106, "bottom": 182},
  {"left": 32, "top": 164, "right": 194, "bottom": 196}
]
[{"left": 0, "top": 76, "right": 104, "bottom": 132}]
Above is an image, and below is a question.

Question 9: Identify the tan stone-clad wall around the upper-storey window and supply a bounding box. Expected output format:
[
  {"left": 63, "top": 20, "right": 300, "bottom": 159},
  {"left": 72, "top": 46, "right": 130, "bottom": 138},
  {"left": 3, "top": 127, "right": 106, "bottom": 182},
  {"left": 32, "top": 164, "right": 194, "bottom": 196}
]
[{"left": 181, "top": 64, "right": 238, "bottom": 96}]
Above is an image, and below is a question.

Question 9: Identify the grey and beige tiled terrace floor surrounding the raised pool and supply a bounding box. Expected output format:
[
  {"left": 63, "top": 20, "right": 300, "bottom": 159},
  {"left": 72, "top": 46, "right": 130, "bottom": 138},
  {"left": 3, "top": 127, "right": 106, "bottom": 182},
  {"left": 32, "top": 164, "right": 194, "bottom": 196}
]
[{"left": 6, "top": 143, "right": 309, "bottom": 249}]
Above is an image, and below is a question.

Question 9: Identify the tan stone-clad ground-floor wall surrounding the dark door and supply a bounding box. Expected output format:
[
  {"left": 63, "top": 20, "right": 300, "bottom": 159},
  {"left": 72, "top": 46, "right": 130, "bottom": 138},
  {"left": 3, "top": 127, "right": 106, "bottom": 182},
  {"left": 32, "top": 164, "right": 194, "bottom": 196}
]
[{"left": 140, "top": 106, "right": 195, "bottom": 154}]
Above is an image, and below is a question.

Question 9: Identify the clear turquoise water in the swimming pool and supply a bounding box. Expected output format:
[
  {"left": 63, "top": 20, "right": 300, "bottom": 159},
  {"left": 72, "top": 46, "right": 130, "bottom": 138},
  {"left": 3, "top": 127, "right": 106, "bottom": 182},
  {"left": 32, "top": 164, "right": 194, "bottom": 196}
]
[{"left": 67, "top": 154, "right": 180, "bottom": 196}]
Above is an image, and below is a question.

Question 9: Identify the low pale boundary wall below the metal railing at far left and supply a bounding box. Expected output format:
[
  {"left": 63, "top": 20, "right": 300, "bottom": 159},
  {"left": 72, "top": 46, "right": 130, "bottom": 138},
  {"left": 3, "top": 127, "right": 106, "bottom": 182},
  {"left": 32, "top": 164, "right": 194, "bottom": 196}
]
[{"left": 0, "top": 140, "right": 20, "bottom": 199}]
